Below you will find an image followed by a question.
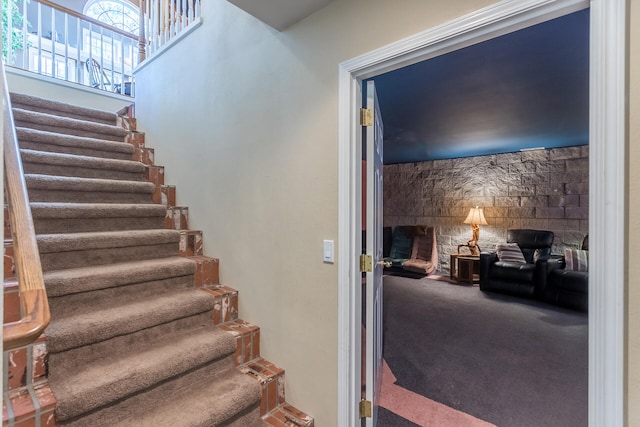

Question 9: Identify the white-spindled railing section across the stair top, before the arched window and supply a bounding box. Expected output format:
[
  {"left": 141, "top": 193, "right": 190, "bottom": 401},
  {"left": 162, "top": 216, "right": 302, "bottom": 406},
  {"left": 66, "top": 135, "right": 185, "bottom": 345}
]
[{"left": 0, "top": 0, "right": 139, "bottom": 95}]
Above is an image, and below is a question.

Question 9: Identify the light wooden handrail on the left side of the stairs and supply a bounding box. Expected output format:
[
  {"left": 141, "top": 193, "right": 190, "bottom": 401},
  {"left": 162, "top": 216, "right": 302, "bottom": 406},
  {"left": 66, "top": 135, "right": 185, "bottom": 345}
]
[{"left": 0, "top": 62, "right": 50, "bottom": 350}]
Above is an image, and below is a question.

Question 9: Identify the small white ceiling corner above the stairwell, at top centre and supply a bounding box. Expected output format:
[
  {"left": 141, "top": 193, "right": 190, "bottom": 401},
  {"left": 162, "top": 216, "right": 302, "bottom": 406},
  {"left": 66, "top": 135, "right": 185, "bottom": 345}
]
[{"left": 228, "top": 0, "right": 333, "bottom": 31}]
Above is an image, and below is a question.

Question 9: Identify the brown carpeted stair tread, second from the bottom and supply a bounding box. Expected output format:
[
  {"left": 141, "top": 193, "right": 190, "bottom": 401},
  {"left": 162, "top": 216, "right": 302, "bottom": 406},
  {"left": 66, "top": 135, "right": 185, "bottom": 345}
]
[{"left": 50, "top": 324, "right": 236, "bottom": 420}]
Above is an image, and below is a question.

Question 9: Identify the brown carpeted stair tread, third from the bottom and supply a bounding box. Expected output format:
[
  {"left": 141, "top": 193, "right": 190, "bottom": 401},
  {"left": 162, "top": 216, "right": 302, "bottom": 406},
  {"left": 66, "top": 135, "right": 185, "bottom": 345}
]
[{"left": 47, "top": 289, "right": 214, "bottom": 353}]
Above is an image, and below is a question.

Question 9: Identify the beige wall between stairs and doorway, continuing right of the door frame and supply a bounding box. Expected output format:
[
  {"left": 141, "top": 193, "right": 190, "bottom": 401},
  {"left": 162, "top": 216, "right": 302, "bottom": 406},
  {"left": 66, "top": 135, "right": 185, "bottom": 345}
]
[{"left": 136, "top": 0, "right": 640, "bottom": 426}]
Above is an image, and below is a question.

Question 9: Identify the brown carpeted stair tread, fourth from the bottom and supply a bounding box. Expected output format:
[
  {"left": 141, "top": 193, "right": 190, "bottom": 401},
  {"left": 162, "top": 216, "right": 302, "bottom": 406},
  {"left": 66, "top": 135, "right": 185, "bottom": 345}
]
[{"left": 44, "top": 256, "right": 196, "bottom": 298}]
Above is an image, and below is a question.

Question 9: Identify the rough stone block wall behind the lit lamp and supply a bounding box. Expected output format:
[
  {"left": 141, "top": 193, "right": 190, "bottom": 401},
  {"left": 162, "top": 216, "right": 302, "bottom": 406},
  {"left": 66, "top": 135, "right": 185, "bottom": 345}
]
[{"left": 384, "top": 145, "right": 589, "bottom": 272}]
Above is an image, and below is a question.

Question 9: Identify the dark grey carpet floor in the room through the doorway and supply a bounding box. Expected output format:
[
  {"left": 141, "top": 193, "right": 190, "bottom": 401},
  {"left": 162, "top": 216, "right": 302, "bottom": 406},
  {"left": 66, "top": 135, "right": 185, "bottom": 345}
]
[{"left": 382, "top": 276, "right": 588, "bottom": 427}]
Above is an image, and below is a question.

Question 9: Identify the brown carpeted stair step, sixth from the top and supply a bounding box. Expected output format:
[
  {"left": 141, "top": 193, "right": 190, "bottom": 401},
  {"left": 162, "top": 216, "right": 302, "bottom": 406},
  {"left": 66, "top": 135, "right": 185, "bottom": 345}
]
[{"left": 31, "top": 202, "right": 166, "bottom": 234}]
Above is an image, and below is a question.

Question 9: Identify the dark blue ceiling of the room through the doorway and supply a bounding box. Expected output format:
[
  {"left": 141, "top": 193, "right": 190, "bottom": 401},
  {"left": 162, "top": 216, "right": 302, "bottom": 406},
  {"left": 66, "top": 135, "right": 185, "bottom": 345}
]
[{"left": 373, "top": 10, "right": 589, "bottom": 164}]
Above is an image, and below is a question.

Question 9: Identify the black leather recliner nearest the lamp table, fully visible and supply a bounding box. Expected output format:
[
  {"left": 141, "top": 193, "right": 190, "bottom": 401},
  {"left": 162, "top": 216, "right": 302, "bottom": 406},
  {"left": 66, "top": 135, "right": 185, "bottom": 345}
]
[{"left": 480, "top": 229, "right": 554, "bottom": 297}]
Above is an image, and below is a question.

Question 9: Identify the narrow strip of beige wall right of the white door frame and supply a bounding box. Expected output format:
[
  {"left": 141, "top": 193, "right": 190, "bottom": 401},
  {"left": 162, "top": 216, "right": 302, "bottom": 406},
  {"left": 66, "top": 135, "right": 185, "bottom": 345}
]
[{"left": 627, "top": 0, "right": 640, "bottom": 427}]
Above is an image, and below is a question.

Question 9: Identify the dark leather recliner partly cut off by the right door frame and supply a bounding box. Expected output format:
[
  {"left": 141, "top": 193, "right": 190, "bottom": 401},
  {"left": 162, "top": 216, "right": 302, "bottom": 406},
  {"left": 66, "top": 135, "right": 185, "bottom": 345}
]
[{"left": 538, "top": 235, "right": 589, "bottom": 312}]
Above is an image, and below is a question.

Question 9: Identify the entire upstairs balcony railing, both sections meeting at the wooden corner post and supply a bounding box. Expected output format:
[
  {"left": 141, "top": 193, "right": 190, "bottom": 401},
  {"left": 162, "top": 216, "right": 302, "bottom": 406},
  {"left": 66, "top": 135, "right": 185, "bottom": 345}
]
[{"left": 1, "top": 0, "right": 200, "bottom": 95}]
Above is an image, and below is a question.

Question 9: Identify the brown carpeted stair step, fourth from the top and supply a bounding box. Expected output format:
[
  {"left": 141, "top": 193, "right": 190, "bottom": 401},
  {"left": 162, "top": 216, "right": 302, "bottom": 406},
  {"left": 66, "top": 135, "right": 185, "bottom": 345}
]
[{"left": 20, "top": 149, "right": 145, "bottom": 181}]
